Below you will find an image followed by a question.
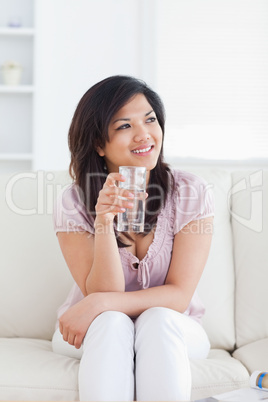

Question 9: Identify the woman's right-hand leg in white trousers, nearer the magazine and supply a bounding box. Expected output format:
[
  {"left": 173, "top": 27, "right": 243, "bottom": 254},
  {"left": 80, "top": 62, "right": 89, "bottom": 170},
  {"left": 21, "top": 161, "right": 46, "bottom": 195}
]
[{"left": 135, "top": 307, "right": 210, "bottom": 401}]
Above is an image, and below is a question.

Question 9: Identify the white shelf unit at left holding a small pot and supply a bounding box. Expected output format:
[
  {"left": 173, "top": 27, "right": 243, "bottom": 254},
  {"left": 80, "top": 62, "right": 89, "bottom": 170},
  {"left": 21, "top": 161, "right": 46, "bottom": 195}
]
[{"left": 0, "top": 0, "right": 35, "bottom": 173}]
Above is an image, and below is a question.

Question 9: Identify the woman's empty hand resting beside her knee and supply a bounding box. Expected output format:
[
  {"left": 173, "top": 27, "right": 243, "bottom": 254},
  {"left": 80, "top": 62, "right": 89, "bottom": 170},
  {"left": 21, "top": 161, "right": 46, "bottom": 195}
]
[{"left": 59, "top": 293, "right": 102, "bottom": 349}]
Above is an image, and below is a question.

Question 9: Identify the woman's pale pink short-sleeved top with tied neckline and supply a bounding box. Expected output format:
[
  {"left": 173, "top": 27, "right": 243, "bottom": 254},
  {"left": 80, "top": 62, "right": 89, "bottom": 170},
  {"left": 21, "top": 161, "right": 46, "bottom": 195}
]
[{"left": 54, "top": 170, "right": 214, "bottom": 322}]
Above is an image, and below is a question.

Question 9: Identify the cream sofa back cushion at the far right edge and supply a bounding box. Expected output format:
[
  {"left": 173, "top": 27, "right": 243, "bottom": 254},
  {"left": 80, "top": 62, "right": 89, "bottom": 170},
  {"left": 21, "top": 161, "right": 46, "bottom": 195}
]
[{"left": 229, "top": 169, "right": 268, "bottom": 347}]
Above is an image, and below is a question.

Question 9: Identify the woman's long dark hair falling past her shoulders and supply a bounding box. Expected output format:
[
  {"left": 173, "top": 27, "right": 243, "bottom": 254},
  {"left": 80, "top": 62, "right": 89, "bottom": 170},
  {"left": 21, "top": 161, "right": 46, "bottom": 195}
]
[{"left": 68, "top": 75, "right": 172, "bottom": 247}]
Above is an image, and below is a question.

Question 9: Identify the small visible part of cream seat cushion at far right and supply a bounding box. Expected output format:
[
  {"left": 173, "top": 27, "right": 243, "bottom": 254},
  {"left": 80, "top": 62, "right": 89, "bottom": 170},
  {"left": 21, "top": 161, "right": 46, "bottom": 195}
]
[{"left": 233, "top": 338, "right": 268, "bottom": 373}]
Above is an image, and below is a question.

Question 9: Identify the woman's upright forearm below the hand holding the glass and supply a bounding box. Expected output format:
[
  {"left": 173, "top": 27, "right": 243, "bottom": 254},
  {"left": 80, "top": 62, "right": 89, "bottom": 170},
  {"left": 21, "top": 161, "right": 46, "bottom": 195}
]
[{"left": 86, "top": 221, "right": 125, "bottom": 294}]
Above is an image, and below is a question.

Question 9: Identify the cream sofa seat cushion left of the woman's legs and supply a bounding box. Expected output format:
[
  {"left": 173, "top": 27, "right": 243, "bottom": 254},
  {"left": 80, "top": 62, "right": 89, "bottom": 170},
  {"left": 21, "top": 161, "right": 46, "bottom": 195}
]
[{"left": 0, "top": 338, "right": 79, "bottom": 401}]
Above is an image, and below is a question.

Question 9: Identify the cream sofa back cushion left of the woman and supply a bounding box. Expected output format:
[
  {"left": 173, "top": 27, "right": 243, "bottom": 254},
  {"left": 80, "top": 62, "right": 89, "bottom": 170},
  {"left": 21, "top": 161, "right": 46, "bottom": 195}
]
[{"left": 0, "top": 171, "right": 73, "bottom": 339}]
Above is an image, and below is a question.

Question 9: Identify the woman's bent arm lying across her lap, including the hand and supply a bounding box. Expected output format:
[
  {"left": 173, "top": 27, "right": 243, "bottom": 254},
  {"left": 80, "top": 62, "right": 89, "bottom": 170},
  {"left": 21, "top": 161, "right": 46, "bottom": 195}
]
[{"left": 60, "top": 218, "right": 213, "bottom": 348}]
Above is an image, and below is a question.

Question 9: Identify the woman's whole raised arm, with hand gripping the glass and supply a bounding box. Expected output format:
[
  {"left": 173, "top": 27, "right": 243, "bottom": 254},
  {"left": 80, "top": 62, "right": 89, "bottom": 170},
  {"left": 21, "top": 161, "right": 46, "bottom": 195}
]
[{"left": 58, "top": 173, "right": 135, "bottom": 296}]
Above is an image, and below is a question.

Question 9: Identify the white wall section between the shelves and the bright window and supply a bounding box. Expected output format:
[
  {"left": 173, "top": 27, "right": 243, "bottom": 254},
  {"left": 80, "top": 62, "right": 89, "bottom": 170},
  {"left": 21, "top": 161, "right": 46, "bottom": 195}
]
[{"left": 33, "top": 0, "right": 149, "bottom": 170}]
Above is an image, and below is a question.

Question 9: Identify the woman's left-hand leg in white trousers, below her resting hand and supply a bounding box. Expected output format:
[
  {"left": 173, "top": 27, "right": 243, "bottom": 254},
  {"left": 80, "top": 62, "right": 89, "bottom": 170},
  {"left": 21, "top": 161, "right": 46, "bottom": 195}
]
[{"left": 79, "top": 311, "right": 134, "bottom": 401}]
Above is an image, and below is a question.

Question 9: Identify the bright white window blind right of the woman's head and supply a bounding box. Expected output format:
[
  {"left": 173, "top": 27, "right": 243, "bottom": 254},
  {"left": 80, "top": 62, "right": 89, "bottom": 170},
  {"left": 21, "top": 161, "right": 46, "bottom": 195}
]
[{"left": 155, "top": 0, "right": 268, "bottom": 164}]
